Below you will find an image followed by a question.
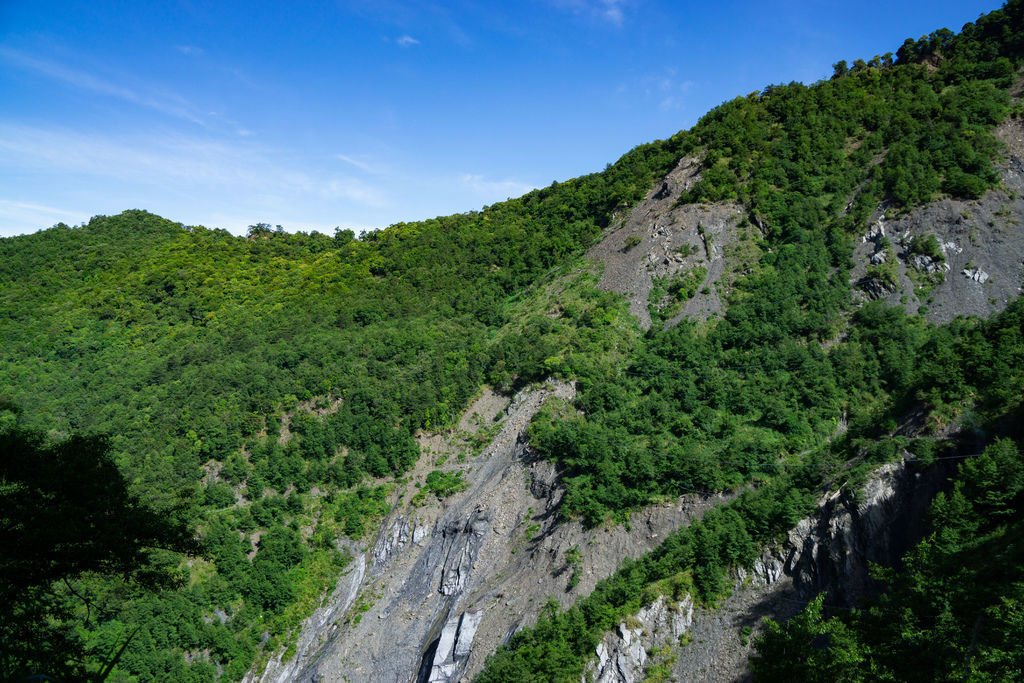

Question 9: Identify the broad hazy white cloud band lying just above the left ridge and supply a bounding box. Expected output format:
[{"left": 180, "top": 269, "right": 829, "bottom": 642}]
[{"left": 0, "top": 123, "right": 535, "bottom": 239}]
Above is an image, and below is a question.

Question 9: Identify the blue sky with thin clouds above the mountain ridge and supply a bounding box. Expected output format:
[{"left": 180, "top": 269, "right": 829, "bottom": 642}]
[{"left": 0, "top": 0, "right": 1001, "bottom": 236}]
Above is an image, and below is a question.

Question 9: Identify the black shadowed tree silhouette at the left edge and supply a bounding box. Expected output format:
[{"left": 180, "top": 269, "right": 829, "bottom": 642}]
[{"left": 0, "top": 428, "right": 199, "bottom": 680}]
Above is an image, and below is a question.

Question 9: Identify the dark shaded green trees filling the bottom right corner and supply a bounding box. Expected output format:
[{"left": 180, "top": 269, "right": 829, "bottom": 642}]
[{"left": 753, "top": 439, "right": 1024, "bottom": 681}]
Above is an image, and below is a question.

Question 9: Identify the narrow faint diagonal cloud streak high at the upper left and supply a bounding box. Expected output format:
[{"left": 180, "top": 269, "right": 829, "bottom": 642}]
[{"left": 0, "top": 47, "right": 206, "bottom": 125}]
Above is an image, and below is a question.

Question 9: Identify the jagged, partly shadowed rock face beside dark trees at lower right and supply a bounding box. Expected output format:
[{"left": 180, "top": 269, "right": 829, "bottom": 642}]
[{"left": 590, "top": 462, "right": 945, "bottom": 683}]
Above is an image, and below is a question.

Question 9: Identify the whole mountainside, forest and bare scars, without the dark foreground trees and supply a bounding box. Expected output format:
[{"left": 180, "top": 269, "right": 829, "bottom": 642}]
[{"left": 0, "top": 0, "right": 1024, "bottom": 681}]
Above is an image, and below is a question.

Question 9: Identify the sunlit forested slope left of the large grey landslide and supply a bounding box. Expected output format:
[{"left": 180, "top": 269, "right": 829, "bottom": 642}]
[{"left": 0, "top": 148, "right": 688, "bottom": 680}]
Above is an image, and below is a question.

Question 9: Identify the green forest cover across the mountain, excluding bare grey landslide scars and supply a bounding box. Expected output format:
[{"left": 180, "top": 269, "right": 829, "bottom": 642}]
[{"left": 0, "top": 2, "right": 1024, "bottom": 680}]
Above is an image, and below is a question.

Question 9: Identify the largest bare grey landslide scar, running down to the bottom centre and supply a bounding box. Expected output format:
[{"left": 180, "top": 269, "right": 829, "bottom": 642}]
[{"left": 250, "top": 383, "right": 726, "bottom": 683}]
